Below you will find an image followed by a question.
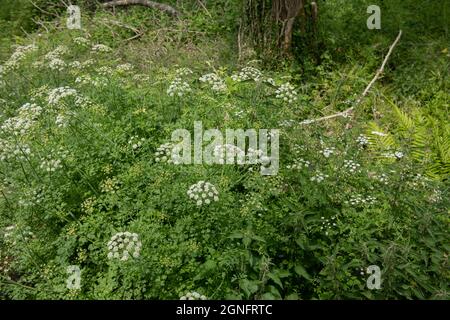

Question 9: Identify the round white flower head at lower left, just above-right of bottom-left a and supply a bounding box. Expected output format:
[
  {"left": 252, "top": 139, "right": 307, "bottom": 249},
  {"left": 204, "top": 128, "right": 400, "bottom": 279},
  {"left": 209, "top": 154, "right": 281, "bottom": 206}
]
[{"left": 108, "top": 231, "right": 142, "bottom": 261}]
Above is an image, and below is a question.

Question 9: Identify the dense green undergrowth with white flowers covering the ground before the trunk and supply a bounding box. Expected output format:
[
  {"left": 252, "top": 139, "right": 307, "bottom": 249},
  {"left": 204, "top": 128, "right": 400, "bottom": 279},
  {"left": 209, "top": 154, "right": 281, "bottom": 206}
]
[{"left": 0, "top": 1, "right": 450, "bottom": 299}]
